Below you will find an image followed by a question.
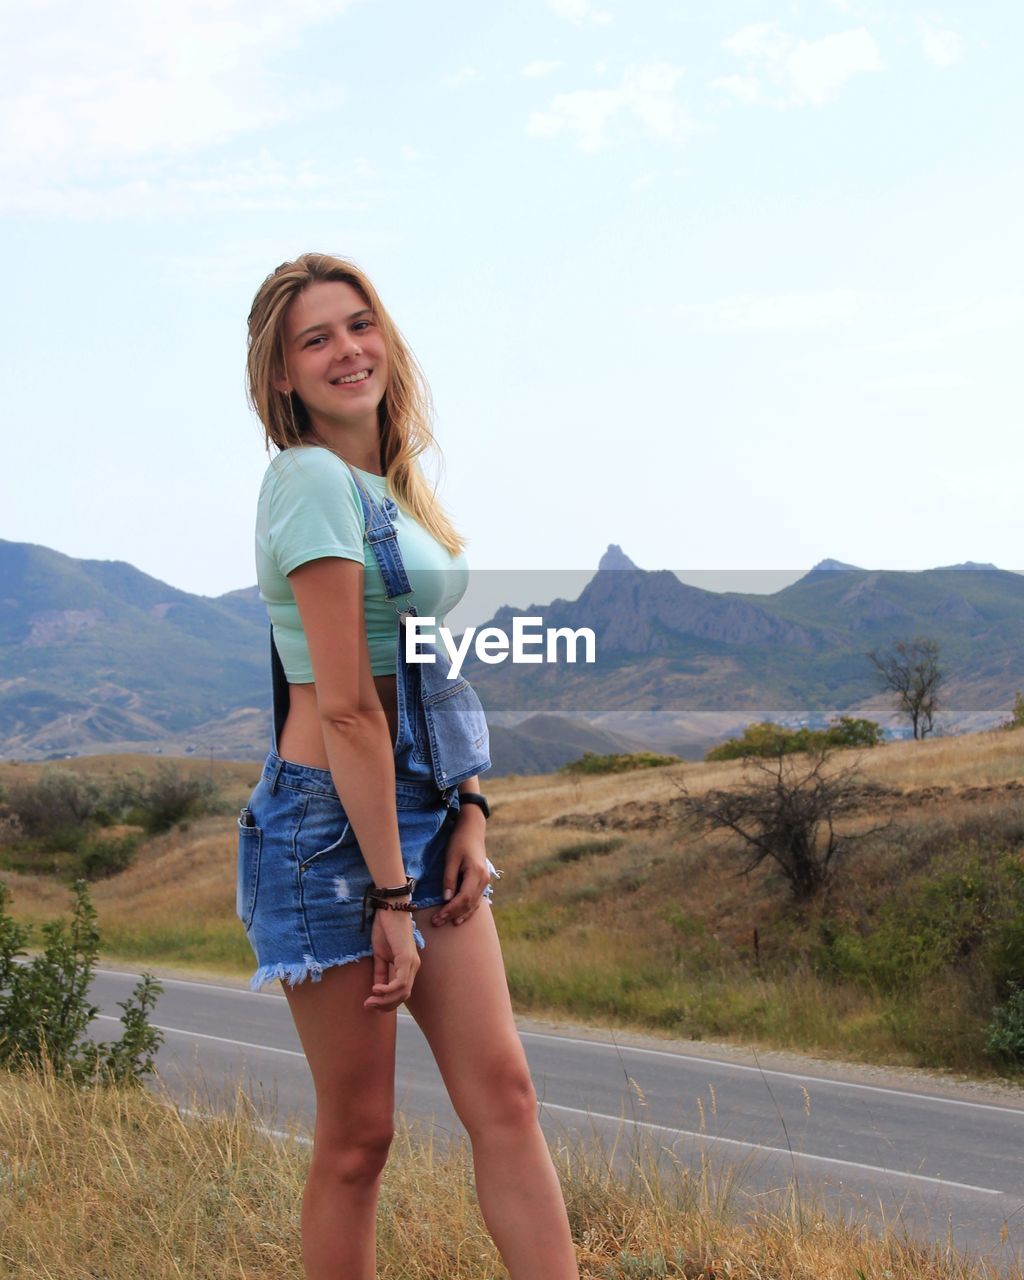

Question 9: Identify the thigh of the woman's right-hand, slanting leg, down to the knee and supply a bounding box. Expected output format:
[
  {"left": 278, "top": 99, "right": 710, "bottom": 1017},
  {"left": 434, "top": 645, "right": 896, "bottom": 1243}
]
[{"left": 407, "top": 904, "right": 536, "bottom": 1133}]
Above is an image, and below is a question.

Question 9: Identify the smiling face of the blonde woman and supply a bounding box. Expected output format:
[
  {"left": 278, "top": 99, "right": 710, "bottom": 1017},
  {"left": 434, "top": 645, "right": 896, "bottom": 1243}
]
[{"left": 274, "top": 280, "right": 388, "bottom": 433}]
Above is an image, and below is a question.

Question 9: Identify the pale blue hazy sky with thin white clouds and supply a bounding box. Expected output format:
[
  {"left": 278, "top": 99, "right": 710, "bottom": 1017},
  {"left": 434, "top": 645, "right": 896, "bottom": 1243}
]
[{"left": 0, "top": 0, "right": 1024, "bottom": 594}]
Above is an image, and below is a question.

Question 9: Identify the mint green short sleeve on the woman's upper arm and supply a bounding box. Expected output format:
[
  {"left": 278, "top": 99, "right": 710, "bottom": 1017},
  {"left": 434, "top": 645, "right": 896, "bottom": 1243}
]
[{"left": 268, "top": 448, "right": 365, "bottom": 577}]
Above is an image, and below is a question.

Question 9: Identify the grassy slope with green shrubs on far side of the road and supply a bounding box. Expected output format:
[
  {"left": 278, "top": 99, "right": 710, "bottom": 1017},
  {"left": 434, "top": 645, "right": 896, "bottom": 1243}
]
[{"left": 0, "top": 728, "right": 1024, "bottom": 1078}]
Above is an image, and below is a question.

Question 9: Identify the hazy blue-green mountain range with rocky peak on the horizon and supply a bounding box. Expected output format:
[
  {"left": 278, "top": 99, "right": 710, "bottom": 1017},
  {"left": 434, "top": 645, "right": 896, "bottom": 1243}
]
[{"left": 0, "top": 540, "right": 1024, "bottom": 772}]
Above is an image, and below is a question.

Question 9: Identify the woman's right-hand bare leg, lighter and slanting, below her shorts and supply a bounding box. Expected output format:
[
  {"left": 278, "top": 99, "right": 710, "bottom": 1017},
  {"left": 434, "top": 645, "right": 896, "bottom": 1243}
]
[{"left": 407, "top": 904, "right": 580, "bottom": 1280}]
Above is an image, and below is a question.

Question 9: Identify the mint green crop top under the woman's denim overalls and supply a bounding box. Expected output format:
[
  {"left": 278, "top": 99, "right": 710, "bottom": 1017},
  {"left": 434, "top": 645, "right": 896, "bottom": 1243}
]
[{"left": 256, "top": 445, "right": 470, "bottom": 685}]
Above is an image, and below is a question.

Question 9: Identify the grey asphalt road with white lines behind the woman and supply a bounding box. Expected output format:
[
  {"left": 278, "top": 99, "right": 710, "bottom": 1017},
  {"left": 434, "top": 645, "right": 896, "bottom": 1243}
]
[{"left": 85, "top": 969, "right": 1024, "bottom": 1263}]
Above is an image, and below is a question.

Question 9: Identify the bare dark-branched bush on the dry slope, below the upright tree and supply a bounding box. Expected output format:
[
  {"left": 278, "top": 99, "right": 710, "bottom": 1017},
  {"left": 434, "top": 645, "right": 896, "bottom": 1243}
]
[{"left": 680, "top": 748, "right": 888, "bottom": 901}]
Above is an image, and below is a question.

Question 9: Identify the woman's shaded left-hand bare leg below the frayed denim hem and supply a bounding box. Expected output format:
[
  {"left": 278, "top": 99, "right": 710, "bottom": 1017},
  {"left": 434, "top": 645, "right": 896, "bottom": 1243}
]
[{"left": 282, "top": 962, "right": 396, "bottom": 1280}]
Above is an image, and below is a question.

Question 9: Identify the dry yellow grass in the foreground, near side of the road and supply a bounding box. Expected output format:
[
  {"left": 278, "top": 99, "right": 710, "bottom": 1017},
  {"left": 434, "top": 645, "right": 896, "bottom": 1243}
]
[{"left": 0, "top": 1075, "right": 1021, "bottom": 1280}]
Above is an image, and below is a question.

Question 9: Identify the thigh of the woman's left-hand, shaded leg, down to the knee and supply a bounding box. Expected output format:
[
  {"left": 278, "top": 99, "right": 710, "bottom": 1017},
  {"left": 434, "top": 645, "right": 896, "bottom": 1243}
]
[{"left": 282, "top": 960, "right": 396, "bottom": 1143}]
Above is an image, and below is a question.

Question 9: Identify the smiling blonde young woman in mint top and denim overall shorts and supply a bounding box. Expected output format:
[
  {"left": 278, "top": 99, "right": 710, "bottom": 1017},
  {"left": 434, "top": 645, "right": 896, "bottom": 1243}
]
[{"left": 237, "top": 253, "right": 579, "bottom": 1280}]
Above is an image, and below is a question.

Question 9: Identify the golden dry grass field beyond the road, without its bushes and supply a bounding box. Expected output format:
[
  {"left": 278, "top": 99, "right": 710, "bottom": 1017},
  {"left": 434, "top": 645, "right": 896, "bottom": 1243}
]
[{"left": 0, "top": 730, "right": 1024, "bottom": 1074}]
